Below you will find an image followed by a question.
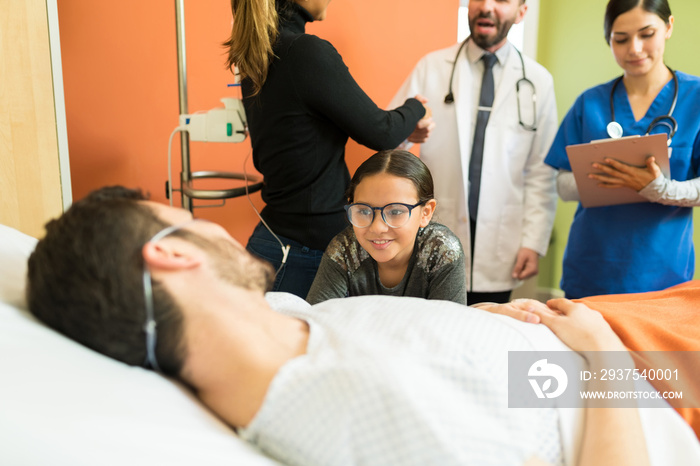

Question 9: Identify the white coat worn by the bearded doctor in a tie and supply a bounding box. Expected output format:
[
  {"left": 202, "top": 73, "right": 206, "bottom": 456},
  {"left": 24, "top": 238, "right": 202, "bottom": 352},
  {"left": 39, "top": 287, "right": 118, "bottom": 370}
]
[{"left": 390, "top": 43, "right": 558, "bottom": 292}]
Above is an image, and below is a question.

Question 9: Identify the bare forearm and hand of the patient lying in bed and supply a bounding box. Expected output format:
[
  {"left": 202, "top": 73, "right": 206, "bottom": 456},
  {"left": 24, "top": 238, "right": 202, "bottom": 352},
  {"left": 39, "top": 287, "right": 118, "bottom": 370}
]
[{"left": 533, "top": 299, "right": 649, "bottom": 466}]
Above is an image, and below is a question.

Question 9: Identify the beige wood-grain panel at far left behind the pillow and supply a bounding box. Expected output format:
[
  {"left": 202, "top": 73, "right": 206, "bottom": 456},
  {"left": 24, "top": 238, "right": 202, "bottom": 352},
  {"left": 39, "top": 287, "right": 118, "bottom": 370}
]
[{"left": 0, "top": 0, "right": 63, "bottom": 237}]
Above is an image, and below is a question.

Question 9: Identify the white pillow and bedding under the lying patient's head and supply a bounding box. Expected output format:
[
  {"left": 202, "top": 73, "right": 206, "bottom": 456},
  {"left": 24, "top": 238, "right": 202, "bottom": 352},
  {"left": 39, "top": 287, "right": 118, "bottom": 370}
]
[{"left": 0, "top": 225, "right": 278, "bottom": 466}]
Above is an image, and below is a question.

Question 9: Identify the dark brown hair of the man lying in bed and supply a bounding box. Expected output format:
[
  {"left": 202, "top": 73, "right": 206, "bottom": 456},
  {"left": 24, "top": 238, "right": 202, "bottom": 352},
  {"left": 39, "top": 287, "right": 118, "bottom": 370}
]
[{"left": 27, "top": 186, "right": 185, "bottom": 376}]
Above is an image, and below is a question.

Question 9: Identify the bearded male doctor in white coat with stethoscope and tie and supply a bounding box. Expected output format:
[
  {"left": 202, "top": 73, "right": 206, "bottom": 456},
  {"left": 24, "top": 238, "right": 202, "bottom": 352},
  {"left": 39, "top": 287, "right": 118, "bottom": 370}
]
[{"left": 391, "top": 0, "right": 558, "bottom": 304}]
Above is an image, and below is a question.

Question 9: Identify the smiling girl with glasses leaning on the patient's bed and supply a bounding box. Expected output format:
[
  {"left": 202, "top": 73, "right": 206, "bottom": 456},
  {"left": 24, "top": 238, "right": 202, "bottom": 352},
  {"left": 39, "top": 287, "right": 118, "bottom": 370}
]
[{"left": 307, "top": 150, "right": 467, "bottom": 304}]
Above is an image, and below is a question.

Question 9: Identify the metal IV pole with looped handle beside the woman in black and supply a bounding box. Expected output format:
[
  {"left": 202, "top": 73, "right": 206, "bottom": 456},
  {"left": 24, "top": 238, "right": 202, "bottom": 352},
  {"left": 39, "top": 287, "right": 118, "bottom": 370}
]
[{"left": 173, "top": 0, "right": 263, "bottom": 212}]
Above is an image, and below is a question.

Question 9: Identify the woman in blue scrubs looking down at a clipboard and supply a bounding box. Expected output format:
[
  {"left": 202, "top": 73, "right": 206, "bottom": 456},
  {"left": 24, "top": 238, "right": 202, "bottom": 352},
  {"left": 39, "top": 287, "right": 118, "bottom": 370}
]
[{"left": 545, "top": 0, "right": 700, "bottom": 298}]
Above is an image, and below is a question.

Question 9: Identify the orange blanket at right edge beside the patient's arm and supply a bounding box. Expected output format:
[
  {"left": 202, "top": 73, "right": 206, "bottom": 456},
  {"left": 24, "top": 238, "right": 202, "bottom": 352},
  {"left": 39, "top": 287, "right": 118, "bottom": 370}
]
[{"left": 577, "top": 280, "right": 700, "bottom": 439}]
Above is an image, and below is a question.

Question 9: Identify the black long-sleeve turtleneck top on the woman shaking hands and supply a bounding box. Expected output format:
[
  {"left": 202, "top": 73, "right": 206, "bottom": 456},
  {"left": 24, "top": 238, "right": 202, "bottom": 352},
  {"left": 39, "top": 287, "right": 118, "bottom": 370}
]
[{"left": 242, "top": 4, "right": 425, "bottom": 250}]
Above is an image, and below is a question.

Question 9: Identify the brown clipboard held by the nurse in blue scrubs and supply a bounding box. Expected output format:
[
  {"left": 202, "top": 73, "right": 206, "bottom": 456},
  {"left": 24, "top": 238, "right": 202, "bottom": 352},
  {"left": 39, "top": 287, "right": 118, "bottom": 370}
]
[{"left": 566, "top": 133, "right": 671, "bottom": 207}]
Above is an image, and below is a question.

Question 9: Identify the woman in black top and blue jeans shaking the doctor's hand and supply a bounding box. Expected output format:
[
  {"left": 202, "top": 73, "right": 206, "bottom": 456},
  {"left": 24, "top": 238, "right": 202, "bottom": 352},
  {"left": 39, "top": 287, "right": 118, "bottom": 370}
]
[{"left": 225, "top": 0, "right": 426, "bottom": 297}]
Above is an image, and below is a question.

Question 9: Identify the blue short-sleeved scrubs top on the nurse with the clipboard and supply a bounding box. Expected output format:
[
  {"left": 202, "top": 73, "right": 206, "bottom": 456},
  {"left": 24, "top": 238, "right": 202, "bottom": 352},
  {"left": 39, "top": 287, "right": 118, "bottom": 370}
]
[{"left": 545, "top": 72, "right": 700, "bottom": 298}]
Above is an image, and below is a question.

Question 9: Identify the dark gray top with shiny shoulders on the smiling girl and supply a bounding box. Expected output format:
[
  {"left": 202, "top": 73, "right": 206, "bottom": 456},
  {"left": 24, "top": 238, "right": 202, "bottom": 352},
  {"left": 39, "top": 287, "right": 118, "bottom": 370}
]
[{"left": 306, "top": 222, "right": 467, "bottom": 304}]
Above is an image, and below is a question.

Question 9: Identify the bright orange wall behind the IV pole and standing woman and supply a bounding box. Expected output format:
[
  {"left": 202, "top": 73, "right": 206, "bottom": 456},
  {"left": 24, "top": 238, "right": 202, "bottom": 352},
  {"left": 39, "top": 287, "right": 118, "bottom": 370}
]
[{"left": 58, "top": 0, "right": 459, "bottom": 243}]
